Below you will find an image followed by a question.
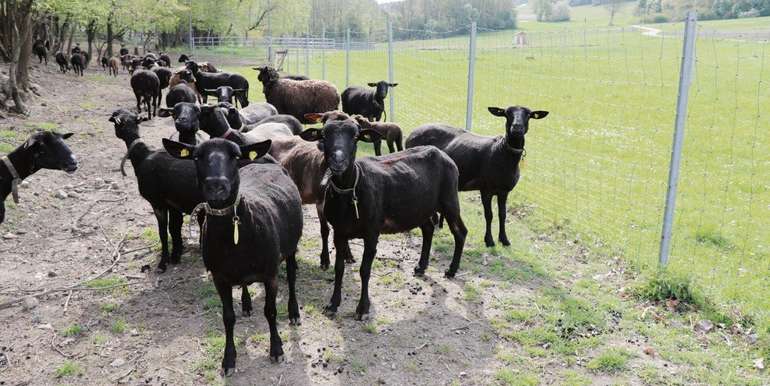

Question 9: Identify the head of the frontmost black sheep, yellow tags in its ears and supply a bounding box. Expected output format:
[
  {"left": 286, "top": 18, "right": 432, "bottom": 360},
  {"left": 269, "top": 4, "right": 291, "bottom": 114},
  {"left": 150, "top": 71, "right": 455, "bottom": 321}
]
[{"left": 163, "top": 138, "right": 271, "bottom": 208}]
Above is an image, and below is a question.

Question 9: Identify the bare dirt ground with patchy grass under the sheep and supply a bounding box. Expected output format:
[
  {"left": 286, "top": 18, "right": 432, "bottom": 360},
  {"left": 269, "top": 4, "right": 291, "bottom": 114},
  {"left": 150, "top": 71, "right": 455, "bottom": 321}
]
[{"left": 0, "top": 64, "right": 760, "bottom": 385}]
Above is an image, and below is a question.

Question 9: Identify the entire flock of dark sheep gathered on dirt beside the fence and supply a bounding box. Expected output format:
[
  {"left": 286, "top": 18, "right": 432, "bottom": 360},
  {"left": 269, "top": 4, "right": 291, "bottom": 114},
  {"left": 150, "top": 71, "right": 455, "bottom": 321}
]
[{"left": 0, "top": 48, "right": 548, "bottom": 375}]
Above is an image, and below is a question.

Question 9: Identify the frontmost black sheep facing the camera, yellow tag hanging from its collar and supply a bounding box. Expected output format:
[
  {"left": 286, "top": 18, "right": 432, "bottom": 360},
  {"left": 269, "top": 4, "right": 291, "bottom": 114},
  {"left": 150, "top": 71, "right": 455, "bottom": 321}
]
[{"left": 163, "top": 138, "right": 302, "bottom": 376}]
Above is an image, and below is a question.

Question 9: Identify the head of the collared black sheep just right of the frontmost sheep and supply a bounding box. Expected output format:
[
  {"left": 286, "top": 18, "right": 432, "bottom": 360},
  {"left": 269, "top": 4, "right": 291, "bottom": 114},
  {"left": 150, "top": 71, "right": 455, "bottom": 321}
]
[{"left": 300, "top": 119, "right": 381, "bottom": 176}]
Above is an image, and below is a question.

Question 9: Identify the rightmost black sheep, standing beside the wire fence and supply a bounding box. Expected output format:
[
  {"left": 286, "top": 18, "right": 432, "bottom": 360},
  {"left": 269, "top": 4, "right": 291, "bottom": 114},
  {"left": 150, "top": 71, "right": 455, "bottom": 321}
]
[{"left": 406, "top": 106, "right": 548, "bottom": 247}]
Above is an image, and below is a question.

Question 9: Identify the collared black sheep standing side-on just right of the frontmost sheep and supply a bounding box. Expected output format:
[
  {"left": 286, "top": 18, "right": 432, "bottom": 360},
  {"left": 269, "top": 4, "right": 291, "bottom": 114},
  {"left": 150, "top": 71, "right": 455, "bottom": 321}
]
[{"left": 300, "top": 119, "right": 467, "bottom": 320}]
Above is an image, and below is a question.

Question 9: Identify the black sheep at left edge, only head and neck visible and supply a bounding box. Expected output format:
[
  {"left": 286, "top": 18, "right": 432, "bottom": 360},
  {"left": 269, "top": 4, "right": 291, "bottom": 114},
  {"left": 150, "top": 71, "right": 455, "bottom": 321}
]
[{"left": 0, "top": 131, "right": 78, "bottom": 224}]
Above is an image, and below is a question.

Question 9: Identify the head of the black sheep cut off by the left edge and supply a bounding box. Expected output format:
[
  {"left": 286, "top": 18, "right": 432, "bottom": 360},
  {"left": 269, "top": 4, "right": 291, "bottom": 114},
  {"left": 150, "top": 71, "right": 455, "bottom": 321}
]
[{"left": 23, "top": 131, "right": 78, "bottom": 174}]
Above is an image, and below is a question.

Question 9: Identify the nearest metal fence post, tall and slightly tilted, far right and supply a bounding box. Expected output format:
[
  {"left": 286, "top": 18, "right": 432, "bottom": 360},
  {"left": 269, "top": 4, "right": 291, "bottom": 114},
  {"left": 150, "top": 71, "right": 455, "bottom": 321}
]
[{"left": 659, "top": 11, "right": 697, "bottom": 267}]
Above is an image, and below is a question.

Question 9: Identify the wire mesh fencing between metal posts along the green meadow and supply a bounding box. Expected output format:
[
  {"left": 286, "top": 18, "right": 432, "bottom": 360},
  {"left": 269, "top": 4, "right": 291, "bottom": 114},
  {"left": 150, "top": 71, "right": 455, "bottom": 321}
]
[{"left": 190, "top": 17, "right": 770, "bottom": 324}]
